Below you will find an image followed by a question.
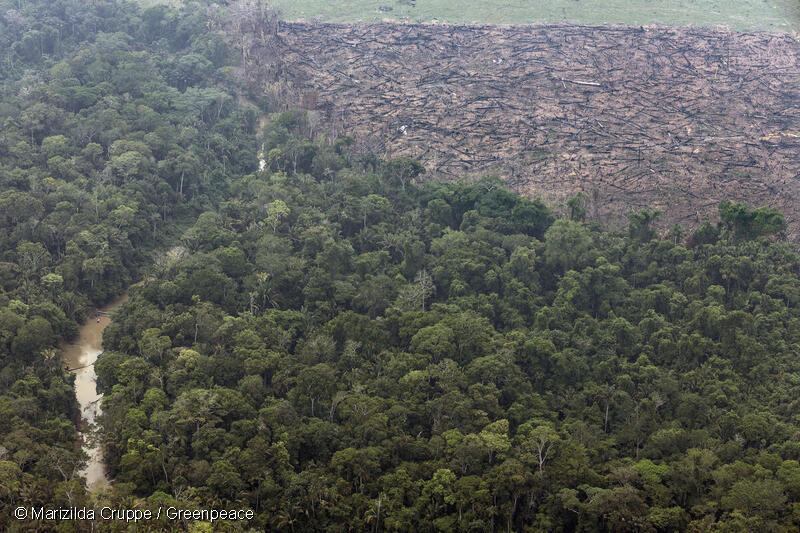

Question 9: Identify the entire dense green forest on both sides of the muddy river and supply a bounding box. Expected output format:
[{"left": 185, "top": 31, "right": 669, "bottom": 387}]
[{"left": 0, "top": 0, "right": 800, "bottom": 532}]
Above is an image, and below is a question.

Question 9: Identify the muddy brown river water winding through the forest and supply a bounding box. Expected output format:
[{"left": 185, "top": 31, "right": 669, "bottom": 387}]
[{"left": 61, "top": 294, "right": 128, "bottom": 490}]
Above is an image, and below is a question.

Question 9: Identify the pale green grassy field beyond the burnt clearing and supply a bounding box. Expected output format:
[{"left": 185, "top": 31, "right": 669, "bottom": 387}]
[{"left": 271, "top": 0, "right": 800, "bottom": 32}]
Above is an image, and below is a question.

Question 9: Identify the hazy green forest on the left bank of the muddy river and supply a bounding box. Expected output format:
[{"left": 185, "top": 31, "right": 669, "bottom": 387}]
[{"left": 0, "top": 0, "right": 258, "bottom": 531}]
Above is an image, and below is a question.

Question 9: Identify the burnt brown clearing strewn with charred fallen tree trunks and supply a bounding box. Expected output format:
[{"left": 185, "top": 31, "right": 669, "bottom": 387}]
[{"left": 251, "top": 23, "right": 800, "bottom": 235}]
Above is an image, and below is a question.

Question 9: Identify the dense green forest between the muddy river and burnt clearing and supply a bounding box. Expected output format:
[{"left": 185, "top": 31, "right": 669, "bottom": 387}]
[{"left": 98, "top": 101, "right": 800, "bottom": 531}]
